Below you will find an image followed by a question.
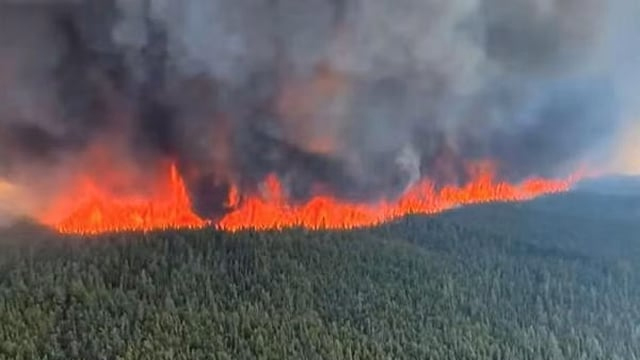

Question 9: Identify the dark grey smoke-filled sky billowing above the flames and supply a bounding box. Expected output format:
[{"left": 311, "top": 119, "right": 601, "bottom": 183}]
[{"left": 0, "top": 0, "right": 640, "bottom": 216}]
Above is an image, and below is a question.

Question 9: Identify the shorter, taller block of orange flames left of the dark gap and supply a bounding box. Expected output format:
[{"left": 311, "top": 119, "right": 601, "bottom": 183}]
[{"left": 45, "top": 165, "right": 207, "bottom": 234}]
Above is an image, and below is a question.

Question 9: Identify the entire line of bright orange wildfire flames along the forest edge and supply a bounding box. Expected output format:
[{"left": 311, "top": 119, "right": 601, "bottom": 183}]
[{"left": 40, "top": 163, "right": 577, "bottom": 234}]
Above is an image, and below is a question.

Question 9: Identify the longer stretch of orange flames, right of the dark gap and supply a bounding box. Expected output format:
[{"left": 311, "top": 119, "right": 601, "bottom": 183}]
[{"left": 217, "top": 163, "right": 575, "bottom": 231}]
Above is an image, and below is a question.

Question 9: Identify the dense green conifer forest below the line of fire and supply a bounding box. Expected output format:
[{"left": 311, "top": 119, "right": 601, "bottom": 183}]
[{"left": 0, "top": 190, "right": 640, "bottom": 360}]
